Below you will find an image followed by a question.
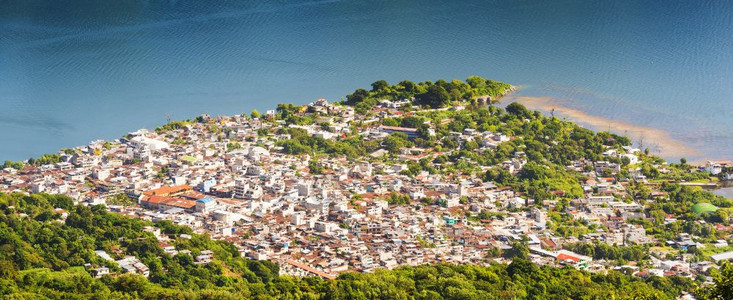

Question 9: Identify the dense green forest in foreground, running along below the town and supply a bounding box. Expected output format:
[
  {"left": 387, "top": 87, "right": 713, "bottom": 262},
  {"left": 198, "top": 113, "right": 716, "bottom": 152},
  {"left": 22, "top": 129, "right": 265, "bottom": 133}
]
[{"left": 0, "top": 194, "right": 733, "bottom": 299}]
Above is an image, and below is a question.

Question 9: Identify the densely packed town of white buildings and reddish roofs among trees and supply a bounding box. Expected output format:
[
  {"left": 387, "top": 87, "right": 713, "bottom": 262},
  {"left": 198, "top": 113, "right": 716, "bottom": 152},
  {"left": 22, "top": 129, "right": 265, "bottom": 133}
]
[{"left": 0, "top": 99, "right": 733, "bottom": 284}]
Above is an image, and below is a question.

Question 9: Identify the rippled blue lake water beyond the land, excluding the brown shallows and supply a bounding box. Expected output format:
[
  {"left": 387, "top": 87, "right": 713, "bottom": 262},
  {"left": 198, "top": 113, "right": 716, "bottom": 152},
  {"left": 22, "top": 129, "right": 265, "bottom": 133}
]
[{"left": 0, "top": 0, "right": 733, "bottom": 160}]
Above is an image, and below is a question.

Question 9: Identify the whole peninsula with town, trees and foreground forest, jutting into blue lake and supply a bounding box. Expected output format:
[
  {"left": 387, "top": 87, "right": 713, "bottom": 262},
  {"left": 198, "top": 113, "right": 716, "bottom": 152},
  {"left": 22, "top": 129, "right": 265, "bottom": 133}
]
[{"left": 0, "top": 76, "right": 733, "bottom": 299}]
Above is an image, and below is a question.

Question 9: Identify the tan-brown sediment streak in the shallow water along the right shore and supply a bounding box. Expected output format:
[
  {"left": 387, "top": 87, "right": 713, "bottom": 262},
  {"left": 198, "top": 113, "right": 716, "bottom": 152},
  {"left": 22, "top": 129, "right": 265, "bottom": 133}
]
[{"left": 513, "top": 97, "right": 700, "bottom": 161}]
